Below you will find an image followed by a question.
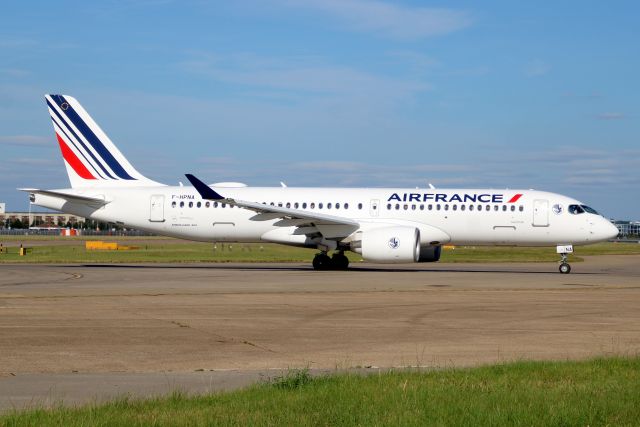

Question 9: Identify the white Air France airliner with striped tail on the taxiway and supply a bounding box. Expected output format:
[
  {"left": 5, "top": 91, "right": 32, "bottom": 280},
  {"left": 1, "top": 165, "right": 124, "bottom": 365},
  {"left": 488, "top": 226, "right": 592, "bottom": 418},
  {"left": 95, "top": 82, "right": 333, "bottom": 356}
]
[{"left": 20, "top": 95, "right": 618, "bottom": 274}]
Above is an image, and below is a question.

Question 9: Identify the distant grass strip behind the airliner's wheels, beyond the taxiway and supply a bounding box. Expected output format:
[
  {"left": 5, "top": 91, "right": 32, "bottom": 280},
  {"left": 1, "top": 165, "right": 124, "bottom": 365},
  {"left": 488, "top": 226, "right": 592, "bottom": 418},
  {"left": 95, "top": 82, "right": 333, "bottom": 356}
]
[{"left": 0, "top": 236, "right": 640, "bottom": 263}]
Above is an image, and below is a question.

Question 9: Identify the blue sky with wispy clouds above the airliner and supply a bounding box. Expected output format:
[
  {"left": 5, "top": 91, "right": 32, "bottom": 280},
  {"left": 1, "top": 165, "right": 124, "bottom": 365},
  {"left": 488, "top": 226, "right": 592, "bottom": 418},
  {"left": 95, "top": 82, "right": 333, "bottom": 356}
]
[{"left": 0, "top": 0, "right": 640, "bottom": 219}]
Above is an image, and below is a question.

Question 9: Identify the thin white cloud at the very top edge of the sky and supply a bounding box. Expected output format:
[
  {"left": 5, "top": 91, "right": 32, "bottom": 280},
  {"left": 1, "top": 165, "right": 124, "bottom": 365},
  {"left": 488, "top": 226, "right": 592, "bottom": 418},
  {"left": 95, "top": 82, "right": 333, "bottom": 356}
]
[{"left": 286, "top": 0, "right": 472, "bottom": 39}]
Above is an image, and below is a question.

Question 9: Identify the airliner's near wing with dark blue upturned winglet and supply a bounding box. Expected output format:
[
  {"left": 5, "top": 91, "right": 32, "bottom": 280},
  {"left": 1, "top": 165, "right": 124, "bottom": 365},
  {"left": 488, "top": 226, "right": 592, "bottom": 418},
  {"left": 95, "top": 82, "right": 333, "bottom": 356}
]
[{"left": 186, "top": 174, "right": 360, "bottom": 239}]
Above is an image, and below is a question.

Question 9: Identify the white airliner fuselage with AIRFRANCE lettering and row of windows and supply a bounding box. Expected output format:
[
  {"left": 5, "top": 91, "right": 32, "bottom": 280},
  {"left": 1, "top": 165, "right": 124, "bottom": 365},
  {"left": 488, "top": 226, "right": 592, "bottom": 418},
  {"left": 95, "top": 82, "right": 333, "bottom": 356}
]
[{"left": 34, "top": 186, "right": 617, "bottom": 246}]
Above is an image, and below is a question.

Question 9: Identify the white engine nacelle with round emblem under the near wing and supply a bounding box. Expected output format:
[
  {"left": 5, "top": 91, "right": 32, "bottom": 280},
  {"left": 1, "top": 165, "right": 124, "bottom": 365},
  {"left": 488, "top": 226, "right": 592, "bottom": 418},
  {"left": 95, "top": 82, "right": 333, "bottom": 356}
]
[{"left": 351, "top": 226, "right": 420, "bottom": 263}]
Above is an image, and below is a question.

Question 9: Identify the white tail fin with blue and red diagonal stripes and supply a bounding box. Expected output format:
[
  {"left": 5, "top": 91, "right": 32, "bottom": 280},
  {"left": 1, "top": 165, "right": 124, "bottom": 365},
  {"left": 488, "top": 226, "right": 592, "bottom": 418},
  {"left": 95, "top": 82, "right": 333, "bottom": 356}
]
[{"left": 45, "top": 95, "right": 162, "bottom": 188}]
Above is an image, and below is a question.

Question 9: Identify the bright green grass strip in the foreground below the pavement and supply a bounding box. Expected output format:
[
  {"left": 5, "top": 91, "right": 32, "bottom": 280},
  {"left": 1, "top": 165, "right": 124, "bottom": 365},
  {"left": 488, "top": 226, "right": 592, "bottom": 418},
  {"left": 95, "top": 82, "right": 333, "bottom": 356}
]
[{"left": 0, "top": 357, "right": 640, "bottom": 426}]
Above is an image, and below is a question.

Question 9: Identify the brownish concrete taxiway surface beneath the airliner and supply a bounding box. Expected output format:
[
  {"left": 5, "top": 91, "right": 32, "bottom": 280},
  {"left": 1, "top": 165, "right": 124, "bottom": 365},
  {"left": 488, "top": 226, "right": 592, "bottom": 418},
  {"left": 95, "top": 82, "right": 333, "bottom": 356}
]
[{"left": 0, "top": 256, "right": 640, "bottom": 409}]
